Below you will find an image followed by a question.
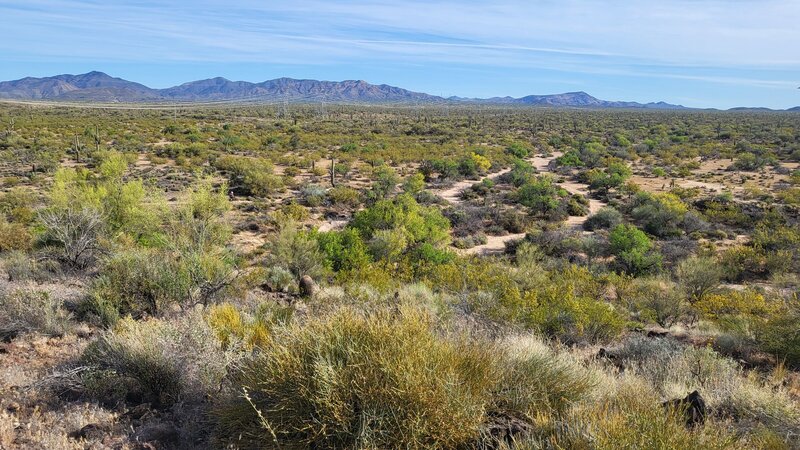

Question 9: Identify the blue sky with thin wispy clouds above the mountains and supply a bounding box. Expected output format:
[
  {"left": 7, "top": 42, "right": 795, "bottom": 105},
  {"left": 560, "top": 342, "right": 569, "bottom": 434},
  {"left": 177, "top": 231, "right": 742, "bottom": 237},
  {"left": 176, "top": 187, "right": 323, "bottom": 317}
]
[{"left": 0, "top": 0, "right": 800, "bottom": 108}]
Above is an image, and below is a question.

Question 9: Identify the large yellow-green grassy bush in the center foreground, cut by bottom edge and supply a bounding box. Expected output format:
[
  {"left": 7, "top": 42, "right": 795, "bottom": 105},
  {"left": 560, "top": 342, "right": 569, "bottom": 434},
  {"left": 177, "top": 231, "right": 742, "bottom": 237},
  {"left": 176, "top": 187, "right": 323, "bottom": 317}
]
[{"left": 214, "top": 306, "right": 591, "bottom": 448}]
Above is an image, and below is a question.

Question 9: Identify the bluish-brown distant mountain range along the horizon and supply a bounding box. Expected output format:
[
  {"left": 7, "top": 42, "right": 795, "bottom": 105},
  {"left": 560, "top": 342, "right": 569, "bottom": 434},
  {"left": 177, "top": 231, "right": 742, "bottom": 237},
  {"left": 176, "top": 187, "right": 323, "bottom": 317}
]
[{"left": 0, "top": 72, "right": 800, "bottom": 111}]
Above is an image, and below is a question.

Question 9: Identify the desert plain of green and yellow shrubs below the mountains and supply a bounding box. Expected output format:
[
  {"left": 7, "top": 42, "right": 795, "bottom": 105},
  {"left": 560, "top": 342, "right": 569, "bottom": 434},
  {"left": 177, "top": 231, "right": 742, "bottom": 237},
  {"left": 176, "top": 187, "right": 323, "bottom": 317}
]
[{"left": 0, "top": 95, "right": 800, "bottom": 449}]
